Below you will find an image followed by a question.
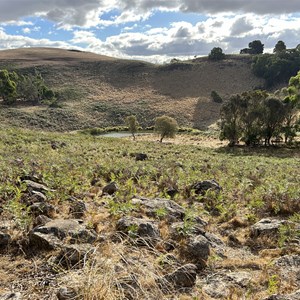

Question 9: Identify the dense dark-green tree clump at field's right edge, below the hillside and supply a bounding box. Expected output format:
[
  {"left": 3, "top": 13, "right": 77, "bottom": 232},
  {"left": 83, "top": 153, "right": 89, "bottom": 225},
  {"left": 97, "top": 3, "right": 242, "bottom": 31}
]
[{"left": 220, "top": 72, "right": 300, "bottom": 146}]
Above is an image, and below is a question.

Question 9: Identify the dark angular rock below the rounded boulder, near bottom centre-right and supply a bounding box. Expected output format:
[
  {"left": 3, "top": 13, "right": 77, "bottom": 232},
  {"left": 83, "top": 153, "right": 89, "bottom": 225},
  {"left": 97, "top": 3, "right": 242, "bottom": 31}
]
[{"left": 162, "top": 264, "right": 197, "bottom": 289}]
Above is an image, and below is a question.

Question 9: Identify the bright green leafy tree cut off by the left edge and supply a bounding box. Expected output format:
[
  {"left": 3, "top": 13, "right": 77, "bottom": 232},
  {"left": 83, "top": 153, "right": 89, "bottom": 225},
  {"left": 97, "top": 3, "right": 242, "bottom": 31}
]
[{"left": 0, "top": 70, "right": 18, "bottom": 104}]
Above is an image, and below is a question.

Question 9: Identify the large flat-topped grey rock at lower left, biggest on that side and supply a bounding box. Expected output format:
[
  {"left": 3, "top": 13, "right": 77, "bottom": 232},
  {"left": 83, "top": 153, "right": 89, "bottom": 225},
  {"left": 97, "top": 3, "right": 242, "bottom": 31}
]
[{"left": 29, "top": 219, "right": 97, "bottom": 249}]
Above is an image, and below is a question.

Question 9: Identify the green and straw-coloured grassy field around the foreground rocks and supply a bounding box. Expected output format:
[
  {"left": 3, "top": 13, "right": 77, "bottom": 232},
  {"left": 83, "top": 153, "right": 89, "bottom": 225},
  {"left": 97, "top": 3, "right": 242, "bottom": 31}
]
[{"left": 0, "top": 128, "right": 300, "bottom": 299}]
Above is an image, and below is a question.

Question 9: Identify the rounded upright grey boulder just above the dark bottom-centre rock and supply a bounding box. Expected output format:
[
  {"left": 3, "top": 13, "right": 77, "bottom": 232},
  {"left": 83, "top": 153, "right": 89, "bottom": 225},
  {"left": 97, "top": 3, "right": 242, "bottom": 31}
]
[{"left": 182, "top": 235, "right": 210, "bottom": 269}]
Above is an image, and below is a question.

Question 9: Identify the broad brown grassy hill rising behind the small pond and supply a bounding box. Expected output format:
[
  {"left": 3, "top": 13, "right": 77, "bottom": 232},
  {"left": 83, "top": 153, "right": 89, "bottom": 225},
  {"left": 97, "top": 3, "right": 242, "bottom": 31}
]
[{"left": 0, "top": 48, "right": 264, "bottom": 130}]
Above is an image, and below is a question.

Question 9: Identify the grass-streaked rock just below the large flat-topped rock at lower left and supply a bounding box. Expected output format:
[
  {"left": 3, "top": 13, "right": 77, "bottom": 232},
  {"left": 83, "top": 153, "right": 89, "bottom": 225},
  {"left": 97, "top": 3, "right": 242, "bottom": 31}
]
[{"left": 56, "top": 244, "right": 96, "bottom": 269}]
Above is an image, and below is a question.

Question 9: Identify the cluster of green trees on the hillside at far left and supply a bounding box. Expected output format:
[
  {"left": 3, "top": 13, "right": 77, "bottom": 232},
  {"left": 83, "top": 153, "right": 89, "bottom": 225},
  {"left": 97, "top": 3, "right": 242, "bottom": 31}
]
[{"left": 0, "top": 69, "right": 55, "bottom": 104}]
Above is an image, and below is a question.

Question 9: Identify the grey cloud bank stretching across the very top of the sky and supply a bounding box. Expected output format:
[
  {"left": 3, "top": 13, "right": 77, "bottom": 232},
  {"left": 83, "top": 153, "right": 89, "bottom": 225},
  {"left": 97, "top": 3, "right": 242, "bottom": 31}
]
[{"left": 0, "top": 0, "right": 300, "bottom": 28}]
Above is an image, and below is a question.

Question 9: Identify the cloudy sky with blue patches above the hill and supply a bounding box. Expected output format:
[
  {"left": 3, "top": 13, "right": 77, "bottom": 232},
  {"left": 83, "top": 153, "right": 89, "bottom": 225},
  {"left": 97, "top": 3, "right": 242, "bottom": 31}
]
[{"left": 0, "top": 0, "right": 300, "bottom": 63}]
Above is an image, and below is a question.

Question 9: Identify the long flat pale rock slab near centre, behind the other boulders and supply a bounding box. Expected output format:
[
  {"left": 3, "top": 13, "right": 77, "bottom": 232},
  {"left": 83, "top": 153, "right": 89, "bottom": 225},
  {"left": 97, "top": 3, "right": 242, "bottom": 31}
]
[{"left": 131, "top": 198, "right": 185, "bottom": 221}]
